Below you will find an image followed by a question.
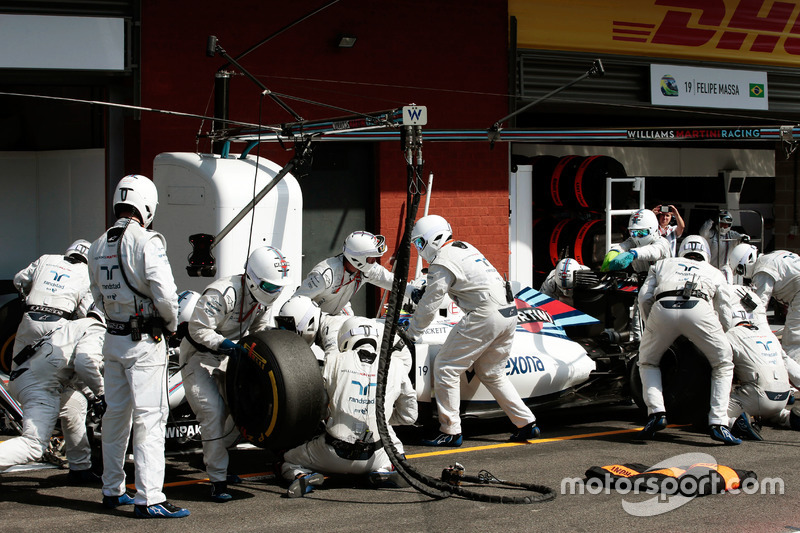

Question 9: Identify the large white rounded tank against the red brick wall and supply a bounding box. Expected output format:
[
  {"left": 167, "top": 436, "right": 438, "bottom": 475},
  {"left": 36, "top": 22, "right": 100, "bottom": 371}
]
[{"left": 153, "top": 152, "right": 303, "bottom": 309}]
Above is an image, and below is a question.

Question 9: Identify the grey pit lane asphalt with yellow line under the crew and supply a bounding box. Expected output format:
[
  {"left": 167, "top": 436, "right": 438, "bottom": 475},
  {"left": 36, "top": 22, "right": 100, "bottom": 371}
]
[{"left": 0, "top": 406, "right": 800, "bottom": 533}]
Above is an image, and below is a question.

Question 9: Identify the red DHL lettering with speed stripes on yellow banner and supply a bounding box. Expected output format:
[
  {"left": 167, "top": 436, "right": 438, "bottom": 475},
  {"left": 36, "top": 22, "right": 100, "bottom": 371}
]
[{"left": 612, "top": 0, "right": 800, "bottom": 55}]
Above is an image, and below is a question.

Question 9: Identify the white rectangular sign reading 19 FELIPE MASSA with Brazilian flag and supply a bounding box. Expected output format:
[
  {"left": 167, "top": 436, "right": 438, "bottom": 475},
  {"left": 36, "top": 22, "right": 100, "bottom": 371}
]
[{"left": 650, "top": 64, "right": 769, "bottom": 109}]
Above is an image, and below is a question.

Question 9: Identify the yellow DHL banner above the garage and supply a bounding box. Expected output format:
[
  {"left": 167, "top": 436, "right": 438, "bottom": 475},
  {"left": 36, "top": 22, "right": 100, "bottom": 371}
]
[{"left": 508, "top": 0, "right": 800, "bottom": 67}]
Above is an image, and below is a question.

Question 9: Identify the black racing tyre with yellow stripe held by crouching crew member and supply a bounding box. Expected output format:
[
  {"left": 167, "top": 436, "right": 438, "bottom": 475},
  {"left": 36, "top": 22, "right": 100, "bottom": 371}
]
[{"left": 225, "top": 329, "right": 325, "bottom": 452}]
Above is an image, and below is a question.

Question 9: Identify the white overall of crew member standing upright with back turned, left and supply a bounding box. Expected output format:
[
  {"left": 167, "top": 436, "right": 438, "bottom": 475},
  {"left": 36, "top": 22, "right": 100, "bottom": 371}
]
[{"left": 89, "top": 219, "right": 178, "bottom": 505}]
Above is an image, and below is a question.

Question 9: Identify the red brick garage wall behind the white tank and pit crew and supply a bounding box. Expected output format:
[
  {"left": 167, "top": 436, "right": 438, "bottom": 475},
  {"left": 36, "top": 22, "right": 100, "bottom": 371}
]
[{"left": 136, "top": 0, "right": 508, "bottom": 272}]
